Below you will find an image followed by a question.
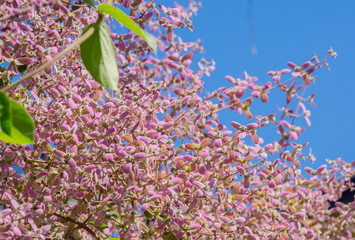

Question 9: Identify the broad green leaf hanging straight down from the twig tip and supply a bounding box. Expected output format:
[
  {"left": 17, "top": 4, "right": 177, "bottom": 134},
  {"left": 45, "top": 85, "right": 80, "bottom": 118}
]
[{"left": 80, "top": 22, "right": 119, "bottom": 90}]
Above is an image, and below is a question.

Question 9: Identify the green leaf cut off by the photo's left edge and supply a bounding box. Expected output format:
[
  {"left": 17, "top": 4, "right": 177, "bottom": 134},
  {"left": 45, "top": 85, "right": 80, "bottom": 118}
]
[{"left": 0, "top": 92, "right": 35, "bottom": 144}]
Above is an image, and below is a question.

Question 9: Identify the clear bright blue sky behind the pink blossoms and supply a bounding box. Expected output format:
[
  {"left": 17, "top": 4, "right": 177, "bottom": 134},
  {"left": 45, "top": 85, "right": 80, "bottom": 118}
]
[{"left": 177, "top": 0, "right": 355, "bottom": 167}]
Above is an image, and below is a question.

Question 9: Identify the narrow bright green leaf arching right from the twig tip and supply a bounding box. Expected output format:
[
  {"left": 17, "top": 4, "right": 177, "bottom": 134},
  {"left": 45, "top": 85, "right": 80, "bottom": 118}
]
[{"left": 97, "top": 4, "right": 157, "bottom": 55}]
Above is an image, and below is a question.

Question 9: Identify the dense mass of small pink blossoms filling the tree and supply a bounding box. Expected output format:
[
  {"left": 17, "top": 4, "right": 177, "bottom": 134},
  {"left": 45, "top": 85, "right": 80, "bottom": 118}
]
[{"left": 0, "top": 0, "right": 355, "bottom": 239}]
